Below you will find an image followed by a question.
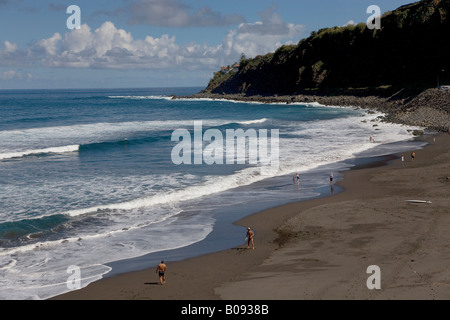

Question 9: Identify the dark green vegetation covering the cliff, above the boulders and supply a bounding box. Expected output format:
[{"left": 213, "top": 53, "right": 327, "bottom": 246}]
[{"left": 204, "top": 0, "right": 450, "bottom": 95}]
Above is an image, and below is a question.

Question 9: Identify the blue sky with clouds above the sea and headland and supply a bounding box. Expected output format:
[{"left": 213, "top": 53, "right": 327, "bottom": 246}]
[{"left": 0, "top": 0, "right": 414, "bottom": 89}]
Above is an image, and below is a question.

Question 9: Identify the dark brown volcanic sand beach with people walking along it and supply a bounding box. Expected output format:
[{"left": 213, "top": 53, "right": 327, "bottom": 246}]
[{"left": 53, "top": 134, "right": 450, "bottom": 300}]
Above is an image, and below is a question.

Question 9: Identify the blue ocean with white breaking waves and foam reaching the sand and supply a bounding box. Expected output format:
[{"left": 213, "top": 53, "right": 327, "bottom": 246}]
[{"left": 0, "top": 88, "right": 423, "bottom": 299}]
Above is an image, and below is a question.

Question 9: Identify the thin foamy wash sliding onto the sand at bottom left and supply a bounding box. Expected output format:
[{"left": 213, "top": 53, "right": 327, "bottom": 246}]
[{"left": 0, "top": 212, "right": 214, "bottom": 299}]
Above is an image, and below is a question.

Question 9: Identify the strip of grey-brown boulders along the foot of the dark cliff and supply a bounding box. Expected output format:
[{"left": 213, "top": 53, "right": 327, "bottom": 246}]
[{"left": 174, "top": 89, "right": 450, "bottom": 132}]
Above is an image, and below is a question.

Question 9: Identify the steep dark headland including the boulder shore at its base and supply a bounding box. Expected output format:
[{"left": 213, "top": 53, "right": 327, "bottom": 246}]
[{"left": 194, "top": 0, "right": 450, "bottom": 132}]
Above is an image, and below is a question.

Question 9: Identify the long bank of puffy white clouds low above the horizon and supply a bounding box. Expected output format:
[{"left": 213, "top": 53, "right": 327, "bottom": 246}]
[{"left": 0, "top": 5, "right": 305, "bottom": 70}]
